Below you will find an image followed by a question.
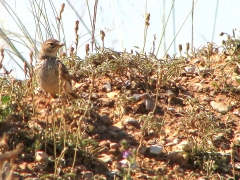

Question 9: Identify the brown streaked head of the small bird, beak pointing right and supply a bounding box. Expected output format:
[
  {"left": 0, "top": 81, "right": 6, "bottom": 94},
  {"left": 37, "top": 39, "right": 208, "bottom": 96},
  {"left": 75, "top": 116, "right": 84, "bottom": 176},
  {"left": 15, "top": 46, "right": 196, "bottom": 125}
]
[{"left": 40, "top": 39, "right": 65, "bottom": 57}]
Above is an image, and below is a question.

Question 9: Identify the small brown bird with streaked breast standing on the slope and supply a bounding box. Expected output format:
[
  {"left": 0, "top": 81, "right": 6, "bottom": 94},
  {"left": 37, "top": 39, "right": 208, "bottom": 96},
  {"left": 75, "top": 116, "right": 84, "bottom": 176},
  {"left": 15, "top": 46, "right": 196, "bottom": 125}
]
[{"left": 35, "top": 39, "right": 79, "bottom": 99}]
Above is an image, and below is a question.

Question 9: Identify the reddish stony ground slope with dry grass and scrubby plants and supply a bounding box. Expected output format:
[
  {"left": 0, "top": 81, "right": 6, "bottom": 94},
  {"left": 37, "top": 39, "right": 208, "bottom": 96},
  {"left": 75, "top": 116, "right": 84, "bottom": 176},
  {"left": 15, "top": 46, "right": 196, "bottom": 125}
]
[{"left": 0, "top": 33, "right": 240, "bottom": 179}]
